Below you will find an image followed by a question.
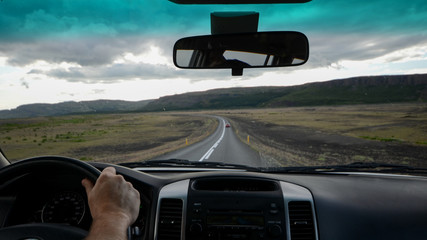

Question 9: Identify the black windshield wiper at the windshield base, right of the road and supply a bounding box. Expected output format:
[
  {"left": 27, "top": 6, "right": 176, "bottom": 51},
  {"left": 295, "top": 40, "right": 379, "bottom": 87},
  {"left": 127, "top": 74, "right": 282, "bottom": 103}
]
[{"left": 264, "top": 162, "right": 427, "bottom": 175}]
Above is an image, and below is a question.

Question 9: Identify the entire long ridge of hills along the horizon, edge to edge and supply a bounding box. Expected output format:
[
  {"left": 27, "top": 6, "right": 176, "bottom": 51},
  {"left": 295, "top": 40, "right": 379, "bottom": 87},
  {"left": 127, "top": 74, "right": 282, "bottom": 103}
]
[{"left": 0, "top": 74, "right": 427, "bottom": 119}]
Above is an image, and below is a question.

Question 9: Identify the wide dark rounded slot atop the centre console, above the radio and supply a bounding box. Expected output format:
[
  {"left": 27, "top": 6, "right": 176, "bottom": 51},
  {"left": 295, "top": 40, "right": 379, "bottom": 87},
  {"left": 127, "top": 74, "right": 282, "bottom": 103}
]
[{"left": 192, "top": 178, "right": 279, "bottom": 192}]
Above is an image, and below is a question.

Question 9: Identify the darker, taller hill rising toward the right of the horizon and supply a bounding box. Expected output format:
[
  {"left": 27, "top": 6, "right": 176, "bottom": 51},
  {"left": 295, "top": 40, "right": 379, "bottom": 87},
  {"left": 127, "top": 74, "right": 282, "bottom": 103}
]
[{"left": 144, "top": 74, "right": 427, "bottom": 111}]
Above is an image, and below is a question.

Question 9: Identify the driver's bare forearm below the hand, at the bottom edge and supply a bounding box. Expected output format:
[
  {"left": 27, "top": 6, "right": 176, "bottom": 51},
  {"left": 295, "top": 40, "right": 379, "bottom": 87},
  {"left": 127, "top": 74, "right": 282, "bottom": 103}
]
[{"left": 85, "top": 218, "right": 128, "bottom": 240}]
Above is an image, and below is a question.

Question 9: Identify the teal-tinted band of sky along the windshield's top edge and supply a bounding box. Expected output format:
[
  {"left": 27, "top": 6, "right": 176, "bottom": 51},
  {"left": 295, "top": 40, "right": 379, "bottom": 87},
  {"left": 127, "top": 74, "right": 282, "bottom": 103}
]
[{"left": 0, "top": 0, "right": 427, "bottom": 40}]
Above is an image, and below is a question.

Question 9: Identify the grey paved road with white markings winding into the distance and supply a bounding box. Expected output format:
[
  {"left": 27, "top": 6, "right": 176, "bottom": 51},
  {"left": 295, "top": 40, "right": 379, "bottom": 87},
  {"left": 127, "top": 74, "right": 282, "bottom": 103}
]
[{"left": 156, "top": 117, "right": 263, "bottom": 167}]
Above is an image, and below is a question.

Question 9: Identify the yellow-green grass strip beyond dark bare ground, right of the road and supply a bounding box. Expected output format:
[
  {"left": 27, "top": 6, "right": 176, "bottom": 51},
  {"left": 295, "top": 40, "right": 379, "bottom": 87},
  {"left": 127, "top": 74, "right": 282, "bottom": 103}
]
[{"left": 219, "top": 104, "right": 427, "bottom": 145}]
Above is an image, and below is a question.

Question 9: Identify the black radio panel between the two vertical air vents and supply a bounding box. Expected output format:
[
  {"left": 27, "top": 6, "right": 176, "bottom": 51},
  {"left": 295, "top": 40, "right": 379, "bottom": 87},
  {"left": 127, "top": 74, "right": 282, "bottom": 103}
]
[{"left": 185, "top": 178, "right": 286, "bottom": 240}]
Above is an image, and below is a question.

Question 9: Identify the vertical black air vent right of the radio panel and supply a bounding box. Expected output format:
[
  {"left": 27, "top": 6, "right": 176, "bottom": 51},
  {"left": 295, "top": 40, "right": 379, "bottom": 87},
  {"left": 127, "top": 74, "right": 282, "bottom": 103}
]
[{"left": 288, "top": 201, "right": 316, "bottom": 240}]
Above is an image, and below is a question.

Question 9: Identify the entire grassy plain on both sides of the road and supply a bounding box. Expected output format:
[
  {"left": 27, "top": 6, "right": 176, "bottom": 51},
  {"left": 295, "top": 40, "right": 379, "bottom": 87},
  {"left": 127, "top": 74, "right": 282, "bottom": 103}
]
[{"left": 0, "top": 103, "right": 427, "bottom": 167}]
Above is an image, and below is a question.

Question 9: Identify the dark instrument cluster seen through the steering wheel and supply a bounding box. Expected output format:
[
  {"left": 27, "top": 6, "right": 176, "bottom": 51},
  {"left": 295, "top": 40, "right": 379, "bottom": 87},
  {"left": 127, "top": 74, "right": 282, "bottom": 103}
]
[{"left": 3, "top": 174, "right": 91, "bottom": 229}]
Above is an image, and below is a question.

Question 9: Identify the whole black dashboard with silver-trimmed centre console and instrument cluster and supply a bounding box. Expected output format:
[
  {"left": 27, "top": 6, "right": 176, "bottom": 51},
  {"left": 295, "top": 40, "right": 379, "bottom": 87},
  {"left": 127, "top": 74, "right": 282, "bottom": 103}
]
[{"left": 0, "top": 160, "right": 427, "bottom": 240}]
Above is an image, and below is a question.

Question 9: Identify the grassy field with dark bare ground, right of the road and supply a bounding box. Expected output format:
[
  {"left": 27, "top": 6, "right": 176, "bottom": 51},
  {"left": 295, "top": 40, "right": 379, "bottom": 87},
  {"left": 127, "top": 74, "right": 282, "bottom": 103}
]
[{"left": 216, "top": 104, "right": 427, "bottom": 167}]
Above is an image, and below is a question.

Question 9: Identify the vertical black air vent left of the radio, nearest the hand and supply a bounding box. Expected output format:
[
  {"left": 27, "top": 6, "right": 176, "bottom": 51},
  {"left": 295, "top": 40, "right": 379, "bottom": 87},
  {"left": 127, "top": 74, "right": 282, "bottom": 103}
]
[{"left": 157, "top": 198, "right": 183, "bottom": 240}]
